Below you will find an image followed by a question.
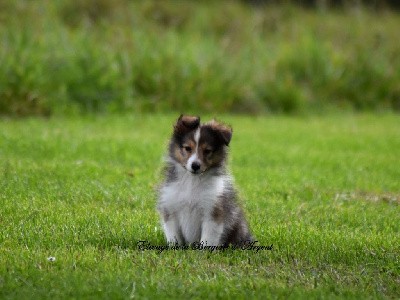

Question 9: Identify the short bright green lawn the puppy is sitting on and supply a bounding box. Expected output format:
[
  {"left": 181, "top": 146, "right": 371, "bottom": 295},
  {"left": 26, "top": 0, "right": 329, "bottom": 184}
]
[{"left": 0, "top": 114, "right": 400, "bottom": 299}]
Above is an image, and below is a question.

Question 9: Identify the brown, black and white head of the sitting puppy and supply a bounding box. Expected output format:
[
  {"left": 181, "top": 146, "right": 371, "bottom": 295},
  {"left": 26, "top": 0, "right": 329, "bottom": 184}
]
[{"left": 170, "top": 115, "right": 232, "bottom": 174}]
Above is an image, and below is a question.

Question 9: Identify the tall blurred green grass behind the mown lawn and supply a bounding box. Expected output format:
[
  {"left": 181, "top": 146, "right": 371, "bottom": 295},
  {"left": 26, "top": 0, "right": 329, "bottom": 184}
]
[{"left": 0, "top": 0, "right": 400, "bottom": 116}]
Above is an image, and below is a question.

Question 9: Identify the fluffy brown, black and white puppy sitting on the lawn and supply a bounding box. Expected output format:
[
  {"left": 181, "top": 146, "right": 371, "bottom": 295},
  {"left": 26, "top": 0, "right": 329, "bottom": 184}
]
[{"left": 157, "top": 115, "right": 253, "bottom": 246}]
